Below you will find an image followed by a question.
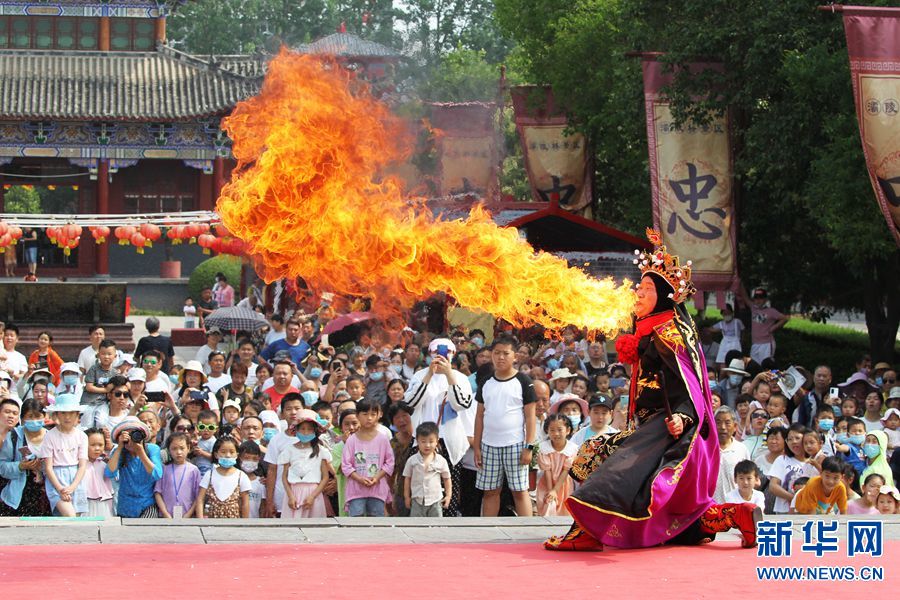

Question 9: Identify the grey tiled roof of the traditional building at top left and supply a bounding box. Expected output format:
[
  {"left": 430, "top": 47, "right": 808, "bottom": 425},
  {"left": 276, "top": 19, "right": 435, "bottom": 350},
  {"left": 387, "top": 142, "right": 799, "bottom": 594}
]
[{"left": 0, "top": 49, "right": 262, "bottom": 121}]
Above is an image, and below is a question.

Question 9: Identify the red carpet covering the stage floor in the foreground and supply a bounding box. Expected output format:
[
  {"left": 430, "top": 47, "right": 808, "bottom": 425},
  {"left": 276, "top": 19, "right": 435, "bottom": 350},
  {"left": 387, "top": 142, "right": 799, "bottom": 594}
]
[{"left": 0, "top": 541, "right": 900, "bottom": 600}]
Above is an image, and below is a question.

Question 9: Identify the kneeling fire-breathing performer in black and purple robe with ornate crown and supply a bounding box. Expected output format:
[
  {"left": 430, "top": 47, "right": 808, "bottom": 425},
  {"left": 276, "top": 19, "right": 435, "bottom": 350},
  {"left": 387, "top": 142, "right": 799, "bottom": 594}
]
[{"left": 544, "top": 229, "right": 762, "bottom": 551}]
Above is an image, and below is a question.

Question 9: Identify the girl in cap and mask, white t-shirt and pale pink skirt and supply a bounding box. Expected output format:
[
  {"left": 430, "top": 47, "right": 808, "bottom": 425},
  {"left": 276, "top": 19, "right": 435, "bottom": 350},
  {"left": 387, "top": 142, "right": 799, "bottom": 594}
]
[{"left": 278, "top": 409, "right": 329, "bottom": 519}]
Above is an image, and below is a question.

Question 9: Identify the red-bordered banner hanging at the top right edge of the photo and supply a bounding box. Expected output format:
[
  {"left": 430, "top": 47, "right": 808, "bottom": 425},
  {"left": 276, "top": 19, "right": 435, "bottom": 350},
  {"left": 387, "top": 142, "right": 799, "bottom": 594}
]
[{"left": 843, "top": 6, "right": 900, "bottom": 244}]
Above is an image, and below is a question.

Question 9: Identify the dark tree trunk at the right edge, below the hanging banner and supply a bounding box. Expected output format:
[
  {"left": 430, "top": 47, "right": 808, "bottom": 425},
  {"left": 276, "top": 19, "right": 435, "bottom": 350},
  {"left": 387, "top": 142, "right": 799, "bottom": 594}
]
[{"left": 863, "top": 251, "right": 900, "bottom": 364}]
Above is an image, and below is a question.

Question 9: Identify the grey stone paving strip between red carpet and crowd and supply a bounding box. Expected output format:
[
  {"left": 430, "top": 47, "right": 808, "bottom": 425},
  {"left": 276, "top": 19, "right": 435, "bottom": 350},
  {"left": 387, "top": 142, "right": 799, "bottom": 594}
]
[{"left": 0, "top": 515, "right": 900, "bottom": 546}]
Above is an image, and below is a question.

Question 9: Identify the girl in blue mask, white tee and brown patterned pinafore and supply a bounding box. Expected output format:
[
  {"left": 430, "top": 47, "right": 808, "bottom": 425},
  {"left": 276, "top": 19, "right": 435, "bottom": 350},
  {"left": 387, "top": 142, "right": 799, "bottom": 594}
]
[{"left": 197, "top": 436, "right": 252, "bottom": 519}]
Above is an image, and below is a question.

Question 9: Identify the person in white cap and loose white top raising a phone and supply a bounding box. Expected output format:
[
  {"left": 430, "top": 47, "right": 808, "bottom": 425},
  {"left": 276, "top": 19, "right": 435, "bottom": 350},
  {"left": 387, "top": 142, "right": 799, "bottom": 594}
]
[{"left": 404, "top": 338, "right": 475, "bottom": 517}]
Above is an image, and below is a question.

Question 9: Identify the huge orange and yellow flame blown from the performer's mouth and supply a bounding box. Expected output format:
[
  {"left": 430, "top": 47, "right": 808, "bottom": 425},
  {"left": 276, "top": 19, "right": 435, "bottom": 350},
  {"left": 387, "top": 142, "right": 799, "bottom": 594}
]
[{"left": 218, "top": 50, "right": 634, "bottom": 334}]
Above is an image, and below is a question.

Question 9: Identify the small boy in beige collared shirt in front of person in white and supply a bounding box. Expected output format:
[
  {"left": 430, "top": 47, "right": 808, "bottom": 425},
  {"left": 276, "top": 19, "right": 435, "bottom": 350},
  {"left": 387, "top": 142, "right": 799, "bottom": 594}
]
[{"left": 403, "top": 421, "right": 453, "bottom": 517}]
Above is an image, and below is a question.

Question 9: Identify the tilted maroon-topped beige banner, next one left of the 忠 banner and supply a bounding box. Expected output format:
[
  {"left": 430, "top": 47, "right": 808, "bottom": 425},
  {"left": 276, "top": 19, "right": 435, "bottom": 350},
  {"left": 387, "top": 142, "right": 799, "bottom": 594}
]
[{"left": 511, "top": 86, "right": 594, "bottom": 214}]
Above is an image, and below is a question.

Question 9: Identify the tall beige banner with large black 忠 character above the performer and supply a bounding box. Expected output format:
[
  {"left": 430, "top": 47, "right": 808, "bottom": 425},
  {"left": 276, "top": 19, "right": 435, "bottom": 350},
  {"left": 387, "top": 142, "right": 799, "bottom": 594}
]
[{"left": 643, "top": 58, "right": 737, "bottom": 291}]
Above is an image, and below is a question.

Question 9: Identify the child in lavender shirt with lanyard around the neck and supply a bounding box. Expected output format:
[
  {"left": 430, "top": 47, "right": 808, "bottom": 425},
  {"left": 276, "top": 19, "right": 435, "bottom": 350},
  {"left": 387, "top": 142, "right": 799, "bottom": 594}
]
[{"left": 153, "top": 431, "right": 201, "bottom": 519}]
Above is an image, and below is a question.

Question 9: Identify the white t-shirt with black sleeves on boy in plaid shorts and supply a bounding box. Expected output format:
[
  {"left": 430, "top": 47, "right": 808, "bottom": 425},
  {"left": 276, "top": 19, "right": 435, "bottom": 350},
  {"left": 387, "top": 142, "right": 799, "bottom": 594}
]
[{"left": 475, "top": 372, "right": 536, "bottom": 448}]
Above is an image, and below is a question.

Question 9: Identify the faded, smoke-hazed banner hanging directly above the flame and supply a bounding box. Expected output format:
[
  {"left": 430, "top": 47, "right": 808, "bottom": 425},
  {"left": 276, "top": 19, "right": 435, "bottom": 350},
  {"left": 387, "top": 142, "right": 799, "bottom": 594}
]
[{"left": 431, "top": 102, "right": 498, "bottom": 197}]
